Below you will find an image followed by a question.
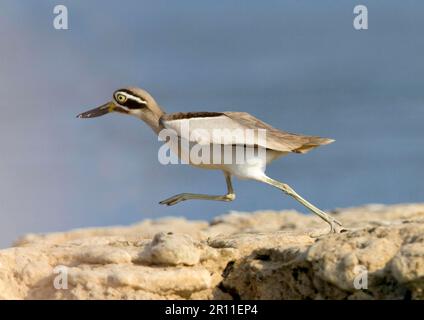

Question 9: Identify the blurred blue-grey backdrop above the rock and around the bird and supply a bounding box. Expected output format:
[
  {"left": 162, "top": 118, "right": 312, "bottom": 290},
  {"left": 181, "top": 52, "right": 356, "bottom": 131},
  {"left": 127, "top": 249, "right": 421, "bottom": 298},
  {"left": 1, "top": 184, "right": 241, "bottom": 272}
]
[{"left": 0, "top": 0, "right": 424, "bottom": 247}]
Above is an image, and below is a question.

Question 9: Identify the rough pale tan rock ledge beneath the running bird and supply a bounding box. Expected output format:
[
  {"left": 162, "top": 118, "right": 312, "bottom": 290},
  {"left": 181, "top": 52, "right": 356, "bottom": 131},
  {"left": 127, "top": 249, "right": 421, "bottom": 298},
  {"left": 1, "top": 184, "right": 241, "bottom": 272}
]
[{"left": 0, "top": 204, "right": 424, "bottom": 299}]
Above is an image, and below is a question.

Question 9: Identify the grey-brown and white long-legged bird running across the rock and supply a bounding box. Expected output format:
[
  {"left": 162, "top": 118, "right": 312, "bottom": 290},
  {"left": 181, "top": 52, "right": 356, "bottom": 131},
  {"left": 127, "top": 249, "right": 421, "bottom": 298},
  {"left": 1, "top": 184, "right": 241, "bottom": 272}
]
[{"left": 77, "top": 87, "right": 346, "bottom": 233}]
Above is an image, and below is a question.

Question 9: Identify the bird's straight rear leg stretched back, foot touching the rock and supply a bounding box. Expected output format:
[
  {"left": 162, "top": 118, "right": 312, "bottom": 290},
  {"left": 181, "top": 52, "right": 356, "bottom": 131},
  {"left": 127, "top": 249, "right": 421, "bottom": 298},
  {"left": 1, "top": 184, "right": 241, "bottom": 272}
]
[{"left": 260, "top": 177, "right": 345, "bottom": 233}]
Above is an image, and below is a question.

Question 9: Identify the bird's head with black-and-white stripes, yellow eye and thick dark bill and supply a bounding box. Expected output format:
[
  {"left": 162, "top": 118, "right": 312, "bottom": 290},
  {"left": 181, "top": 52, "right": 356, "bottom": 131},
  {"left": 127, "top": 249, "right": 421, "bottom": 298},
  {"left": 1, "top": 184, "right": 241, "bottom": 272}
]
[{"left": 77, "top": 87, "right": 163, "bottom": 122}]
